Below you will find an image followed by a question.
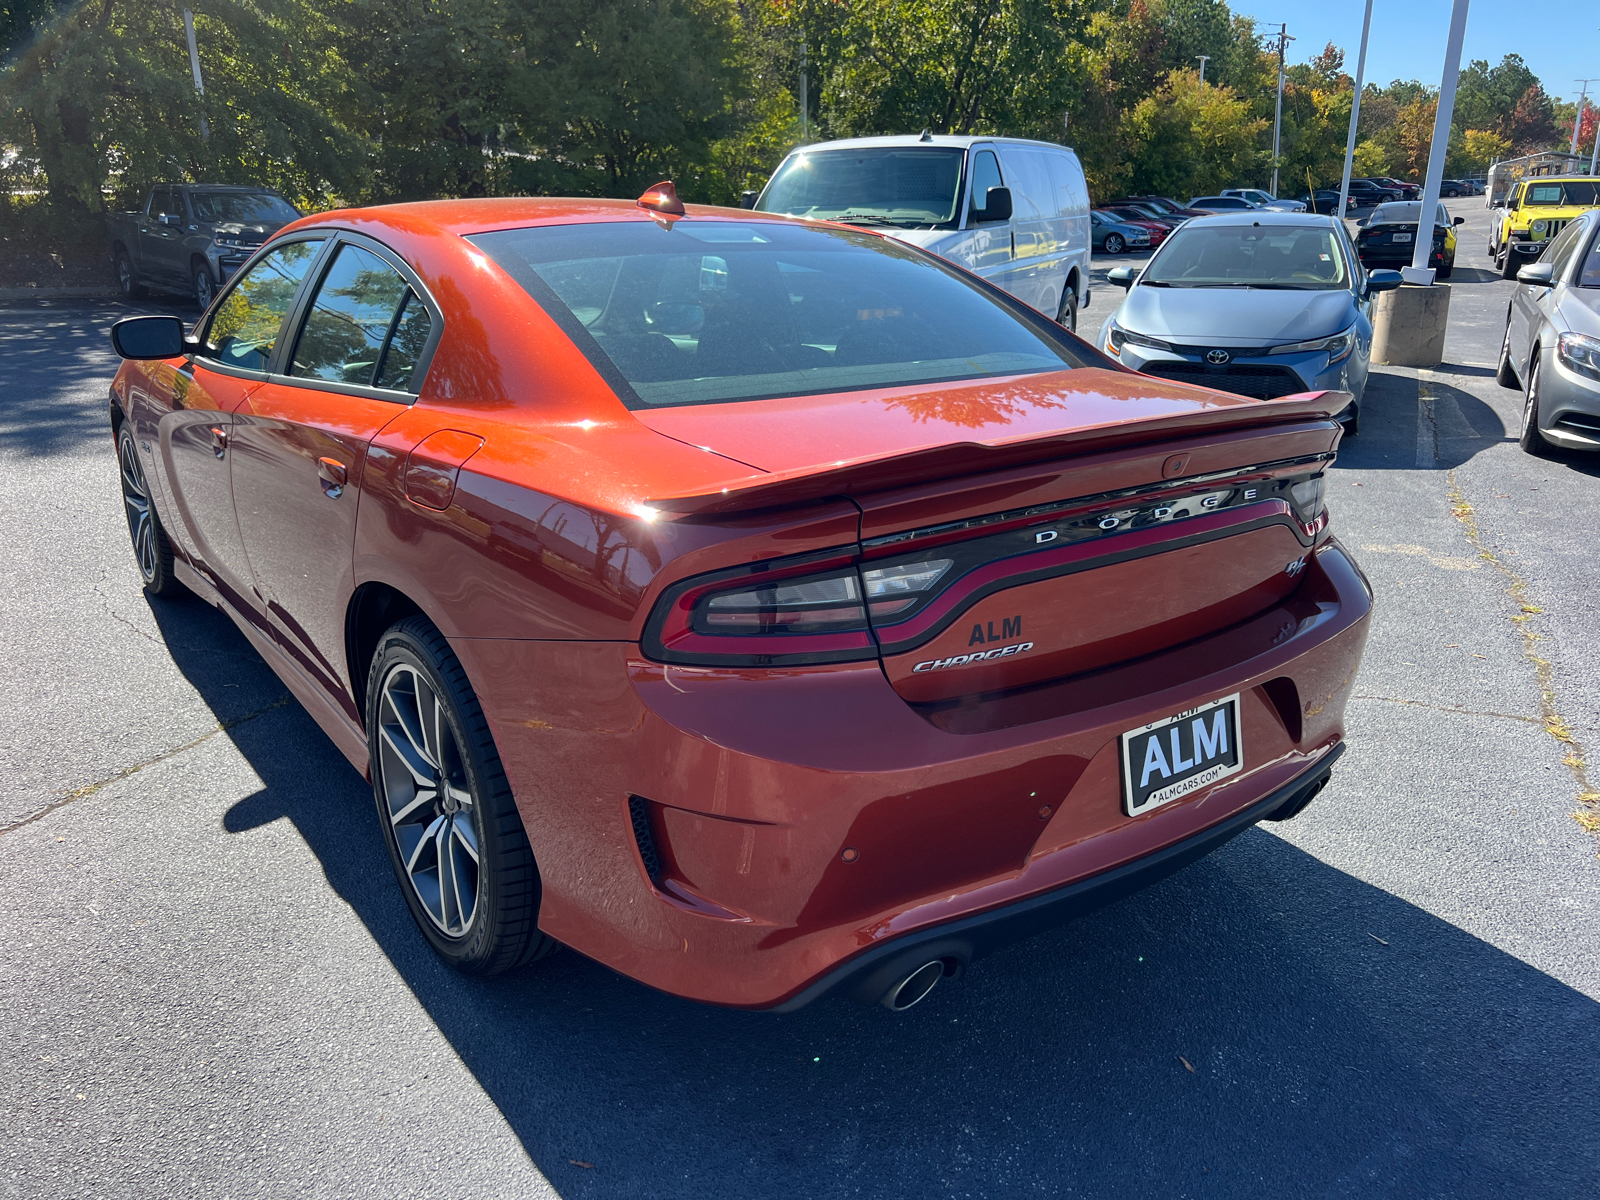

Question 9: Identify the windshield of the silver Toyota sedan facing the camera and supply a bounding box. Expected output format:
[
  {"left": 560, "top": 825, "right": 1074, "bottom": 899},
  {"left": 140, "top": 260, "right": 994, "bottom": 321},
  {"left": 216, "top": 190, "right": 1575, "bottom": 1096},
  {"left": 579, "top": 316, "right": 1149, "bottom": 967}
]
[{"left": 1139, "top": 226, "right": 1350, "bottom": 291}]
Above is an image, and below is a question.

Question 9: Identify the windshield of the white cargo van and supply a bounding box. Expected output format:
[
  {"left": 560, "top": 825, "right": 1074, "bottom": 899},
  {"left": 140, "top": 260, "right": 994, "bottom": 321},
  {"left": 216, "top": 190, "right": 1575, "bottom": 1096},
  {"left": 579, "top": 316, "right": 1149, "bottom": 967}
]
[{"left": 757, "top": 146, "right": 965, "bottom": 229}]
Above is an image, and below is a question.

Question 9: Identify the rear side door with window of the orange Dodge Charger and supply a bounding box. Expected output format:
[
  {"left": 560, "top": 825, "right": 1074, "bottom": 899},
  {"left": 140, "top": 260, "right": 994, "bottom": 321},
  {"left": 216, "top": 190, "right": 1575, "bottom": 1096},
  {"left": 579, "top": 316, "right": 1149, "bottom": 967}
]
[{"left": 232, "top": 235, "right": 442, "bottom": 704}]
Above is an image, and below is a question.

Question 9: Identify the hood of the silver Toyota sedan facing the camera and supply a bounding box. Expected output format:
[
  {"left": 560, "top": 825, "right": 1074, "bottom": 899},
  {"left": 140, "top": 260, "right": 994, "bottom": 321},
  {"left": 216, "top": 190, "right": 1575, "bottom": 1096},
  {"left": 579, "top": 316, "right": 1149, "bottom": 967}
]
[{"left": 1112, "top": 285, "right": 1355, "bottom": 346}]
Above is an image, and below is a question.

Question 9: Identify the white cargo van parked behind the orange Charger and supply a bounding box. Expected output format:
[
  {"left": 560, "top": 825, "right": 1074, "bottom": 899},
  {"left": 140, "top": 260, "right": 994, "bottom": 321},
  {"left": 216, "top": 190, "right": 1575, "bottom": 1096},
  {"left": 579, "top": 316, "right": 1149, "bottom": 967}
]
[{"left": 746, "top": 134, "right": 1090, "bottom": 330}]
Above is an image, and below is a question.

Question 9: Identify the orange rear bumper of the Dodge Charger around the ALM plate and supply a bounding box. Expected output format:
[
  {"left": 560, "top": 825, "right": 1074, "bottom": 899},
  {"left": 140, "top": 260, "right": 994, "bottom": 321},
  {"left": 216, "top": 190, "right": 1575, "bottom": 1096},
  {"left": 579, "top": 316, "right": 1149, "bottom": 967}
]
[{"left": 453, "top": 539, "right": 1371, "bottom": 1010}]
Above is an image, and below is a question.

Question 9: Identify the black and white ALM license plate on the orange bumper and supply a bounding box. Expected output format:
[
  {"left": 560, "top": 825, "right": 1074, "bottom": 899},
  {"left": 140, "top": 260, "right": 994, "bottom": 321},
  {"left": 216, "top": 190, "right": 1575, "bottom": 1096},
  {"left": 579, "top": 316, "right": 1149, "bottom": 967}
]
[{"left": 1122, "top": 693, "right": 1245, "bottom": 816}]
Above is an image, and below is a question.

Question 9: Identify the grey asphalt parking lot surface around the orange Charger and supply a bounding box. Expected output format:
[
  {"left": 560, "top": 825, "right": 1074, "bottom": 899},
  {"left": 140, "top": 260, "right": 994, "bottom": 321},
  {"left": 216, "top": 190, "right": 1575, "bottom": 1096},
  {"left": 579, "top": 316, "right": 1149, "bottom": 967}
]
[{"left": 9, "top": 198, "right": 1600, "bottom": 1200}]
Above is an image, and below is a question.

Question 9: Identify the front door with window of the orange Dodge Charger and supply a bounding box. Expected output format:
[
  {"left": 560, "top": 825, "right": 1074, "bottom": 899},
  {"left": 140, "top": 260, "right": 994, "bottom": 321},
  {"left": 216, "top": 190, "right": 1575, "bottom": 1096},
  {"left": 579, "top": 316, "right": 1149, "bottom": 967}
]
[{"left": 150, "top": 238, "right": 323, "bottom": 611}]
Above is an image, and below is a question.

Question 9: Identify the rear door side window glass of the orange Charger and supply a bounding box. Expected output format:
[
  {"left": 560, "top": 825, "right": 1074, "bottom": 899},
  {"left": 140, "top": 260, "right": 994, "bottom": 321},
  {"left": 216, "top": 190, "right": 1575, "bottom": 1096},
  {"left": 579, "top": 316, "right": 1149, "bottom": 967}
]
[{"left": 290, "top": 243, "right": 432, "bottom": 389}]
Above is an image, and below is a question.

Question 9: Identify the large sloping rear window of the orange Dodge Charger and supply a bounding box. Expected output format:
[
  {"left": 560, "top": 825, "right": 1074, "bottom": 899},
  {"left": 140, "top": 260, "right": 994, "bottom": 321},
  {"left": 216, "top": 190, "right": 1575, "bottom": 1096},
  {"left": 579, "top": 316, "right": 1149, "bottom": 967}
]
[{"left": 470, "top": 219, "right": 1082, "bottom": 408}]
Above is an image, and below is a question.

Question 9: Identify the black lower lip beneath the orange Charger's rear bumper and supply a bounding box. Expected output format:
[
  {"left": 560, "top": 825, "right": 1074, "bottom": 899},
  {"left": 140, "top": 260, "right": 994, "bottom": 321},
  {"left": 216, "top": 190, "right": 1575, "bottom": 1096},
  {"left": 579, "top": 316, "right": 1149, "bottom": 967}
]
[{"left": 771, "top": 742, "right": 1344, "bottom": 1013}]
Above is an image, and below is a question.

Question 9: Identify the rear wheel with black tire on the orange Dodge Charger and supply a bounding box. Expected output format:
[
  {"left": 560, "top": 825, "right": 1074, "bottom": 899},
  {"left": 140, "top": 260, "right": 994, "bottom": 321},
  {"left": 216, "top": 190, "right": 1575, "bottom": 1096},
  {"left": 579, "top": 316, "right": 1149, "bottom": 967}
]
[{"left": 366, "top": 616, "right": 555, "bottom": 976}]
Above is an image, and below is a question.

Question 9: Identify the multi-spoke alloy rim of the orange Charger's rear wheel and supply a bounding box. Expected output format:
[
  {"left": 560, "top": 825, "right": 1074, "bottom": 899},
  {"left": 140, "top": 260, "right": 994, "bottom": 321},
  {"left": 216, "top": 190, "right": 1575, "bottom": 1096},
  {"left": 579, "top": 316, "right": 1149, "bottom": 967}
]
[{"left": 378, "top": 662, "right": 480, "bottom": 938}]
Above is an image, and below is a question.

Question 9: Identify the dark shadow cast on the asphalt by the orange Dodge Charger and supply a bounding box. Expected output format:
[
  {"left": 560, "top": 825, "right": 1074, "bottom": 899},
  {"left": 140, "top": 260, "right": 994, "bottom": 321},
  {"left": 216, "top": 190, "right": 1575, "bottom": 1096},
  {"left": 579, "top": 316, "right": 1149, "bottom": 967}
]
[{"left": 121, "top": 602, "right": 1600, "bottom": 1200}]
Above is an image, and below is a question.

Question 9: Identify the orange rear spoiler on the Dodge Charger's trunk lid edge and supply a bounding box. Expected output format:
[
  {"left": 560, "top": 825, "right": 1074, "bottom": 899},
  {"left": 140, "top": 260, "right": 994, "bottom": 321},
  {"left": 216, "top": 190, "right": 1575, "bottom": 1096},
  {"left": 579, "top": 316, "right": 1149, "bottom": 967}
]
[{"left": 645, "top": 392, "right": 1352, "bottom": 517}]
